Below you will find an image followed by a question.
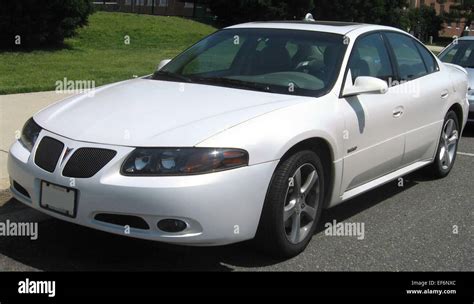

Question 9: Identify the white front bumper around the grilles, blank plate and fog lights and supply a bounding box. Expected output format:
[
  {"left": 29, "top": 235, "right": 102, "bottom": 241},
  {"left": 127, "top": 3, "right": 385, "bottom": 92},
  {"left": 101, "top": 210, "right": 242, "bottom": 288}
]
[{"left": 8, "top": 130, "right": 278, "bottom": 246}]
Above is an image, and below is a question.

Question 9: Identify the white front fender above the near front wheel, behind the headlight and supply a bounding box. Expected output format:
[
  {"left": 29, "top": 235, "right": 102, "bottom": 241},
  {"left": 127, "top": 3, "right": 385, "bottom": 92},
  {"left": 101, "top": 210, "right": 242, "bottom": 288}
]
[{"left": 197, "top": 95, "right": 344, "bottom": 165}]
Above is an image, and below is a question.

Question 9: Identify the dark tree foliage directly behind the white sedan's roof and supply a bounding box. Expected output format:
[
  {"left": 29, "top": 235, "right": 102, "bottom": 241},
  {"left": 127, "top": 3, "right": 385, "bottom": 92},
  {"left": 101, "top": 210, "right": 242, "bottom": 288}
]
[{"left": 208, "top": 0, "right": 440, "bottom": 35}]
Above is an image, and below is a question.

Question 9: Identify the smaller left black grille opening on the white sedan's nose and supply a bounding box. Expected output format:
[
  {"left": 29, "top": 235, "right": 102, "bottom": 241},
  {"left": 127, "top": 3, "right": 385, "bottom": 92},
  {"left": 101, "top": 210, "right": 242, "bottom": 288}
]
[{"left": 35, "top": 136, "right": 64, "bottom": 173}]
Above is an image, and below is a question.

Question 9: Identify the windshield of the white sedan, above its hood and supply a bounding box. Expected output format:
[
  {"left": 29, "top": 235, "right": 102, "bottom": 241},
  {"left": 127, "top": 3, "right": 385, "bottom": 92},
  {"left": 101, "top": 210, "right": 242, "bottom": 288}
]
[{"left": 153, "top": 29, "right": 346, "bottom": 96}]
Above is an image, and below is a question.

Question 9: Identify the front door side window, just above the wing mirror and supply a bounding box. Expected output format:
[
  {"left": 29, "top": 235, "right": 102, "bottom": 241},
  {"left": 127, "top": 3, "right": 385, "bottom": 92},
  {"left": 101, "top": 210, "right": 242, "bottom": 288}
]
[{"left": 349, "top": 34, "right": 393, "bottom": 81}]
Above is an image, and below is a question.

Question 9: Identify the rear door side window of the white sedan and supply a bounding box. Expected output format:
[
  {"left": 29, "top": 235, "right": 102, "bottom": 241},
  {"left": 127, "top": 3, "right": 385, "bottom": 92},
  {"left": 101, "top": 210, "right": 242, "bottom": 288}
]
[{"left": 386, "top": 33, "right": 428, "bottom": 81}]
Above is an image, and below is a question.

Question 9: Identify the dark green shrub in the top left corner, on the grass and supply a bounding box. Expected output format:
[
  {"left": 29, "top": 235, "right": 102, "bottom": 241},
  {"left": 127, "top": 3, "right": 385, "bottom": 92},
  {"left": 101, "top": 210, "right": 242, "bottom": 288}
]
[{"left": 0, "top": 0, "right": 93, "bottom": 49}]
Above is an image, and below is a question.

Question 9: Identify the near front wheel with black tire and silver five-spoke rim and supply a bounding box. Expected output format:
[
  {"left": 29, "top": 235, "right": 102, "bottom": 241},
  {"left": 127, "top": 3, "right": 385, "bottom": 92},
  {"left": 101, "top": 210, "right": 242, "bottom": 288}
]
[{"left": 254, "top": 150, "right": 325, "bottom": 258}]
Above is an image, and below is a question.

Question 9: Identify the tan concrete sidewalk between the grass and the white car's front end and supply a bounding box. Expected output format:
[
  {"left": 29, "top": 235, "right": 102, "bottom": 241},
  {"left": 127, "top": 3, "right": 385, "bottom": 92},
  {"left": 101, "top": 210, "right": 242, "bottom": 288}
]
[{"left": 0, "top": 92, "right": 72, "bottom": 191}]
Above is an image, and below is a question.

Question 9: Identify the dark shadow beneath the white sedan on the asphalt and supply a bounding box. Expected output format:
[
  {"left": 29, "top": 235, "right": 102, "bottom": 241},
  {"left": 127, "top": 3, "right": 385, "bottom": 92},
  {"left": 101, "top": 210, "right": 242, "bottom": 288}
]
[{"left": 0, "top": 175, "right": 418, "bottom": 272}]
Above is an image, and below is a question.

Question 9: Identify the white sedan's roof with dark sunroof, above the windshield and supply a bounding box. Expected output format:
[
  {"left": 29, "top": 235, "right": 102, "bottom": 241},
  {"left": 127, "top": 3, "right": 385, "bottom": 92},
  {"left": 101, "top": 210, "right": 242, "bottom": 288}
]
[{"left": 228, "top": 21, "right": 395, "bottom": 35}]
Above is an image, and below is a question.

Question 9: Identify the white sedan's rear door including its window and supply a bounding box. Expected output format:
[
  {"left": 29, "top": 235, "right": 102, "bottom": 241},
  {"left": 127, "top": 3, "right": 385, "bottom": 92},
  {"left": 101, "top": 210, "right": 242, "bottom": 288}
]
[{"left": 384, "top": 32, "right": 446, "bottom": 166}]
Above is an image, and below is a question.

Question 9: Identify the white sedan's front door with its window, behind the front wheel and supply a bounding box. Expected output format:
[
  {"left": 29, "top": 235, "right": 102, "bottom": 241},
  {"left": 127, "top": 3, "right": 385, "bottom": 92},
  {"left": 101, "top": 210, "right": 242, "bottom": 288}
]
[{"left": 339, "top": 33, "right": 409, "bottom": 195}]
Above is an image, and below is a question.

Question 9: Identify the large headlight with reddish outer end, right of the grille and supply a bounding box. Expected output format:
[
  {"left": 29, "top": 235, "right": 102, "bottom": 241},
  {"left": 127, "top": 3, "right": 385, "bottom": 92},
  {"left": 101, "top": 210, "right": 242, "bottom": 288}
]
[{"left": 121, "top": 148, "right": 249, "bottom": 176}]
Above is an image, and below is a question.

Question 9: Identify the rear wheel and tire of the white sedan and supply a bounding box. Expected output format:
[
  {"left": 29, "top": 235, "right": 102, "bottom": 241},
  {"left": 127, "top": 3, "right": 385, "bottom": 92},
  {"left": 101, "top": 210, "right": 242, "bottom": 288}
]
[{"left": 428, "top": 111, "right": 460, "bottom": 178}]
